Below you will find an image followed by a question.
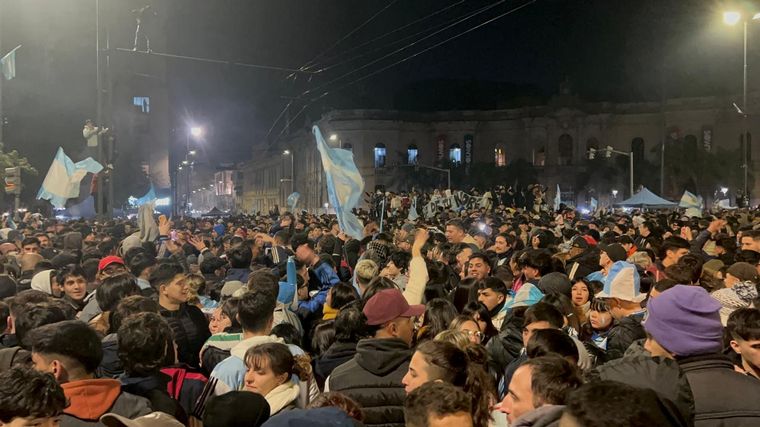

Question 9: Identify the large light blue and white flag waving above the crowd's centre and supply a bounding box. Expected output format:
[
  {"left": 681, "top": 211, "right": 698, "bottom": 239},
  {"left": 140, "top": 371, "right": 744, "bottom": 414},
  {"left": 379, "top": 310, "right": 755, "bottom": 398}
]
[{"left": 312, "top": 126, "right": 364, "bottom": 240}]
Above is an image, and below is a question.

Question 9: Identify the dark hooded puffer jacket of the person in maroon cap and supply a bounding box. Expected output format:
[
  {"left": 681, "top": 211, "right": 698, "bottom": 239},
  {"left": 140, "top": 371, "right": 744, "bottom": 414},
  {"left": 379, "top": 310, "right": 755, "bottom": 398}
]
[{"left": 328, "top": 338, "right": 412, "bottom": 427}]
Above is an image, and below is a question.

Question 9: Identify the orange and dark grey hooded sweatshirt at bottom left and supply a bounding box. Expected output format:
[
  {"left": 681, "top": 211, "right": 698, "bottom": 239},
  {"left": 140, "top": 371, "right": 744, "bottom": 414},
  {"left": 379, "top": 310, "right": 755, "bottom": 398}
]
[{"left": 61, "top": 379, "right": 152, "bottom": 427}]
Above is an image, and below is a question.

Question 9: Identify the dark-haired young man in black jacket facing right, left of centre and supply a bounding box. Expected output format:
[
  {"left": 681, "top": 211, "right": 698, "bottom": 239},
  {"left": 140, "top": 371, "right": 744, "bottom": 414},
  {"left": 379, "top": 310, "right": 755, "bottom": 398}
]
[{"left": 150, "top": 263, "right": 211, "bottom": 368}]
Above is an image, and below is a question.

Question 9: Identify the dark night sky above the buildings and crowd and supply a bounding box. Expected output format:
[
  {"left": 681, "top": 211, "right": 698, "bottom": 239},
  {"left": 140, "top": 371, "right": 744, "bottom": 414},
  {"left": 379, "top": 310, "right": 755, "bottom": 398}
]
[{"left": 0, "top": 0, "right": 760, "bottom": 199}]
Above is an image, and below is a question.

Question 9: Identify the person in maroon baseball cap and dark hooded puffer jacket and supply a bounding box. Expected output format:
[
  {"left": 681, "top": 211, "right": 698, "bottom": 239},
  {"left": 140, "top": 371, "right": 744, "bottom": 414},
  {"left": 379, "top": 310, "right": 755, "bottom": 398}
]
[{"left": 326, "top": 289, "right": 425, "bottom": 426}]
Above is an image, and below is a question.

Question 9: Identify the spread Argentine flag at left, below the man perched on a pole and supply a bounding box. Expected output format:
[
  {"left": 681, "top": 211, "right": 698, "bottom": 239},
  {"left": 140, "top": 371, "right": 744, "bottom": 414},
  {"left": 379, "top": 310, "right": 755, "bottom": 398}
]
[{"left": 37, "top": 147, "right": 103, "bottom": 209}]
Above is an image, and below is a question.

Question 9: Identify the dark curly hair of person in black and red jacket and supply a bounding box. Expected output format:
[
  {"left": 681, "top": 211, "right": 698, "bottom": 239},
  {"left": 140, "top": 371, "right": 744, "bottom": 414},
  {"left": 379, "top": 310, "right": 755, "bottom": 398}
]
[{"left": 117, "top": 313, "right": 175, "bottom": 377}]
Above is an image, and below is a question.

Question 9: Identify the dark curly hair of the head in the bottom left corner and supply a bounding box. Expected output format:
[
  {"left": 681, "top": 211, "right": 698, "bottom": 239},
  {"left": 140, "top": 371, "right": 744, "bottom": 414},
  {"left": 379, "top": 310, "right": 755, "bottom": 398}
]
[{"left": 0, "top": 366, "right": 68, "bottom": 424}]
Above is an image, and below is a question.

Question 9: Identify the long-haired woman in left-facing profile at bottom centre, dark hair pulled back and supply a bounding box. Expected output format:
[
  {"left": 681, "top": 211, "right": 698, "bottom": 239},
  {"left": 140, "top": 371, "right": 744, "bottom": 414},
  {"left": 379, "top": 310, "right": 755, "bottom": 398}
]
[{"left": 401, "top": 341, "right": 496, "bottom": 427}]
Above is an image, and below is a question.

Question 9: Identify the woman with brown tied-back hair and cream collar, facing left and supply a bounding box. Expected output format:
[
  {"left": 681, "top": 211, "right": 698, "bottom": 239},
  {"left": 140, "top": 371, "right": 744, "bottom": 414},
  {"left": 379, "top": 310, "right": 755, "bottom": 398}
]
[{"left": 245, "top": 343, "right": 311, "bottom": 416}]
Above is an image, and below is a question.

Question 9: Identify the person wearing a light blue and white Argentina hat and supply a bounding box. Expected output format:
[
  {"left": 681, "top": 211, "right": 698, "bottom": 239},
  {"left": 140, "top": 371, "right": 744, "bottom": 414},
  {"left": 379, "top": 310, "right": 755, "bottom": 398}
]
[{"left": 595, "top": 261, "right": 646, "bottom": 363}]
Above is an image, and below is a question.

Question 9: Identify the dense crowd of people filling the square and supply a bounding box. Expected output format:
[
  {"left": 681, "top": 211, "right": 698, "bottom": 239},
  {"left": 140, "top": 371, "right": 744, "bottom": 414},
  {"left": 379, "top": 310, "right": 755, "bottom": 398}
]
[{"left": 0, "top": 196, "right": 760, "bottom": 427}]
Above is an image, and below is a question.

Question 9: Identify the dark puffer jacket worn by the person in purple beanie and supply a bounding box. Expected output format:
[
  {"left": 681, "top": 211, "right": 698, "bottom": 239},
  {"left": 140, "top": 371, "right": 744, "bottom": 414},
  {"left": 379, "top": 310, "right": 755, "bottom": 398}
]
[{"left": 678, "top": 354, "right": 760, "bottom": 427}]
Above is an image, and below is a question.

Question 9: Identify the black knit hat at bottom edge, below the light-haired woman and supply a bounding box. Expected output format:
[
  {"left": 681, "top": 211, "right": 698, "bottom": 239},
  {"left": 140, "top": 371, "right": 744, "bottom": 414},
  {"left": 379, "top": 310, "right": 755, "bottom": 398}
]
[{"left": 203, "top": 391, "right": 270, "bottom": 427}]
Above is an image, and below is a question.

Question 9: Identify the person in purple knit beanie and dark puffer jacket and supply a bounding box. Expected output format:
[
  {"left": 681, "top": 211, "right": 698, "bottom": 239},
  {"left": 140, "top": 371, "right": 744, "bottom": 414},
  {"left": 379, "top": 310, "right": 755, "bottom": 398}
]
[{"left": 644, "top": 285, "right": 760, "bottom": 426}]
